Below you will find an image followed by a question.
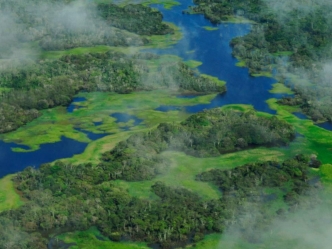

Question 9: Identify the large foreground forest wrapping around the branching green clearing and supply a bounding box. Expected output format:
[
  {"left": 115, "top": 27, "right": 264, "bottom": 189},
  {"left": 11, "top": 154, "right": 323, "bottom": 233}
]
[{"left": 0, "top": 109, "right": 319, "bottom": 249}]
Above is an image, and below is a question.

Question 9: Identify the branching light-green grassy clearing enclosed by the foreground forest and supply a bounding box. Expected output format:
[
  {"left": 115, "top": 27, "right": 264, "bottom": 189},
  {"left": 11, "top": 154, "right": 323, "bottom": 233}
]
[{"left": 115, "top": 138, "right": 307, "bottom": 200}]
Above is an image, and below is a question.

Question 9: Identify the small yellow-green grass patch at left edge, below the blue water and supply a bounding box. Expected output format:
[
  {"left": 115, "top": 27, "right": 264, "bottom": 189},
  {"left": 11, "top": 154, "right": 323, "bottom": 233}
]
[{"left": 0, "top": 175, "right": 23, "bottom": 212}]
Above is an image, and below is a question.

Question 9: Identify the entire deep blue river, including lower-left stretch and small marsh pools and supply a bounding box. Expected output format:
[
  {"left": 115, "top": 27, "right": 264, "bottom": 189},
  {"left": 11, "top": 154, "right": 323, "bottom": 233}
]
[{"left": 0, "top": 0, "right": 332, "bottom": 177}]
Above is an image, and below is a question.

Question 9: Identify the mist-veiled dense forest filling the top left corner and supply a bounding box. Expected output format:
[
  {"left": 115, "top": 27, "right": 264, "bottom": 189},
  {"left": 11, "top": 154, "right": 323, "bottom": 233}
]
[{"left": 0, "top": 0, "right": 174, "bottom": 54}]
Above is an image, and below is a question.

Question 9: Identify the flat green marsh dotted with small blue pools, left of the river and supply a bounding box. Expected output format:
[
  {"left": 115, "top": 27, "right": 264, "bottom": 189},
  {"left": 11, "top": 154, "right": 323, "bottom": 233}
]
[{"left": 1, "top": 89, "right": 216, "bottom": 154}]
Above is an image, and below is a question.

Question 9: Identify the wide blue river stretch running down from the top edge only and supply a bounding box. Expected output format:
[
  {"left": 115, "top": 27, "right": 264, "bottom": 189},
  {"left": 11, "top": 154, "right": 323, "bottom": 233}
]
[{"left": 148, "top": 1, "right": 294, "bottom": 114}]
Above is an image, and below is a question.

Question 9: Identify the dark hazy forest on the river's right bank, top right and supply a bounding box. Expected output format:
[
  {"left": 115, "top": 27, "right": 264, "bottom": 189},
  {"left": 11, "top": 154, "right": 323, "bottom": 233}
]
[{"left": 191, "top": 0, "right": 332, "bottom": 121}]
